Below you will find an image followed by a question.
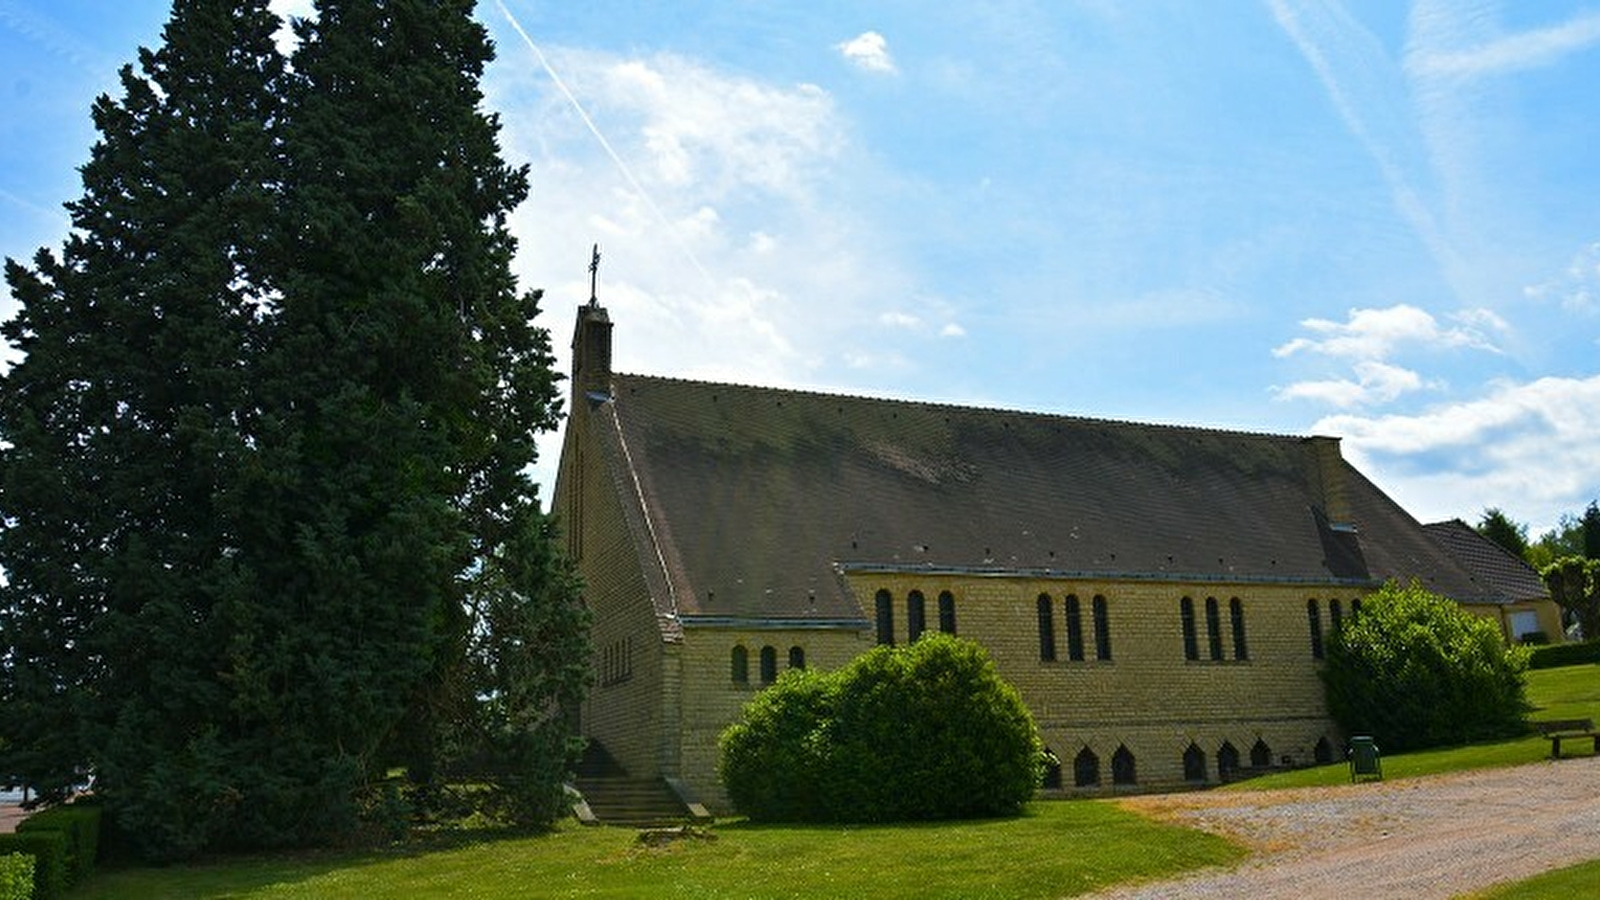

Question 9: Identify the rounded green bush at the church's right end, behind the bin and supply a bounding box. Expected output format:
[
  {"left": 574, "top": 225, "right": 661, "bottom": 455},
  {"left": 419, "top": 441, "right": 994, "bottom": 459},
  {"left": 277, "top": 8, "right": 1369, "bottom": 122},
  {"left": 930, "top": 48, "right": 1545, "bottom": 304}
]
[{"left": 1323, "top": 573, "right": 1528, "bottom": 753}]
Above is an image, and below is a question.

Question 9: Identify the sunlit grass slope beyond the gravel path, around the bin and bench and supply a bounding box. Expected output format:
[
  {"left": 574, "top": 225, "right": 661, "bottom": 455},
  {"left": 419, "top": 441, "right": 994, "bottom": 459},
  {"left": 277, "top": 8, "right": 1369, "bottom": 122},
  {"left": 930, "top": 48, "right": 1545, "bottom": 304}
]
[{"left": 1222, "top": 665, "right": 1600, "bottom": 791}]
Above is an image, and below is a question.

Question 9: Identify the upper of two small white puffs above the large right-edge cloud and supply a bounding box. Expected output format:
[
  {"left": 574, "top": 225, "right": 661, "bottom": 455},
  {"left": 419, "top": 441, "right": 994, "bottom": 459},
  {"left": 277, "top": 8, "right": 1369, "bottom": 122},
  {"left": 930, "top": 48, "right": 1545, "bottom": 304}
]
[{"left": 1272, "top": 303, "right": 1506, "bottom": 360}]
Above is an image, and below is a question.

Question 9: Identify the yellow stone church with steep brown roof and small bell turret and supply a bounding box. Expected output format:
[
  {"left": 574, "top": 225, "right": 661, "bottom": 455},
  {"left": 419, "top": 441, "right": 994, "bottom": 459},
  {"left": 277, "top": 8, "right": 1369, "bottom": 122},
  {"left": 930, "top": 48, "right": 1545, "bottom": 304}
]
[{"left": 552, "top": 301, "right": 1560, "bottom": 809}]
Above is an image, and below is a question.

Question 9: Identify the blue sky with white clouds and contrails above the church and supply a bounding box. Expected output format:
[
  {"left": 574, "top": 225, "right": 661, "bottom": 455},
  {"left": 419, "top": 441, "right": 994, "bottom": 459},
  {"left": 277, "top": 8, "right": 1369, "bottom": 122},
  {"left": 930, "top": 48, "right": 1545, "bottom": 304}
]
[{"left": 0, "top": 0, "right": 1600, "bottom": 533}]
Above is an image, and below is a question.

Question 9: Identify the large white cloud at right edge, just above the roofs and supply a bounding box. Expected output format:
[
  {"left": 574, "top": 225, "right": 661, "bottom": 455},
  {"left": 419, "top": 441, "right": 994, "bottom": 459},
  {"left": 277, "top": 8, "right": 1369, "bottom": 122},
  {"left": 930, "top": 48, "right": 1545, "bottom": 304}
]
[{"left": 1314, "top": 376, "right": 1600, "bottom": 532}]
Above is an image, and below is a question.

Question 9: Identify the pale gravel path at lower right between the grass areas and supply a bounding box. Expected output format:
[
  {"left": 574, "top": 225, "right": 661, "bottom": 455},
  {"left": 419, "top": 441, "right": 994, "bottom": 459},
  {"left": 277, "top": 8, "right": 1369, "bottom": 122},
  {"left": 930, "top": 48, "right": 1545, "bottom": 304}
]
[{"left": 1096, "top": 757, "right": 1600, "bottom": 900}]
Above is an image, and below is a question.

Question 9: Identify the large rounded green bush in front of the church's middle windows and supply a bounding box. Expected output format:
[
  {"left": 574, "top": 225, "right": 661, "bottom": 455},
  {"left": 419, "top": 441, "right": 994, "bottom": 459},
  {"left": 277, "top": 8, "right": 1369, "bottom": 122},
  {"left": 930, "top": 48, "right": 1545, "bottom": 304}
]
[{"left": 720, "top": 633, "right": 1043, "bottom": 822}]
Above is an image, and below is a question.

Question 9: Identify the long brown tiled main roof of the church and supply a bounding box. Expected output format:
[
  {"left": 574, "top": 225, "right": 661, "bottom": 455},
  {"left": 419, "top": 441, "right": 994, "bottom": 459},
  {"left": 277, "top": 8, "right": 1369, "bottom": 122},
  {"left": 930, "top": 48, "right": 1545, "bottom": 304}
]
[{"left": 595, "top": 375, "right": 1482, "bottom": 621}]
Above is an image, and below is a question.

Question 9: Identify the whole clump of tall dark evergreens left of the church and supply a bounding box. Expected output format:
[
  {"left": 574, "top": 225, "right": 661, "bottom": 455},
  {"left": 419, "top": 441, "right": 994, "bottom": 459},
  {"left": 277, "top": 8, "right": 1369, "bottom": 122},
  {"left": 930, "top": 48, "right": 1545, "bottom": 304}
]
[{"left": 0, "top": 0, "right": 586, "bottom": 857}]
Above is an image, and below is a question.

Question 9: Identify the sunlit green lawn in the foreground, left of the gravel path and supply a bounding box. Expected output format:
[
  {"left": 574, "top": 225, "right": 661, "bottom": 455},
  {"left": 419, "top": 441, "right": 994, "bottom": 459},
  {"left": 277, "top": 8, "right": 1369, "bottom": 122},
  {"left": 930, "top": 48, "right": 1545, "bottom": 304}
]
[{"left": 70, "top": 801, "right": 1245, "bottom": 900}]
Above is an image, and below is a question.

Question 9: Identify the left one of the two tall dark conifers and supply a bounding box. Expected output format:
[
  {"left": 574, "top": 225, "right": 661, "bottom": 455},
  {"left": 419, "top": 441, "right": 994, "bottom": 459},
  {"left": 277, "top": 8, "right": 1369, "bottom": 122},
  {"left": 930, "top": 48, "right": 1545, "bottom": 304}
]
[{"left": 0, "top": 0, "right": 282, "bottom": 854}]
